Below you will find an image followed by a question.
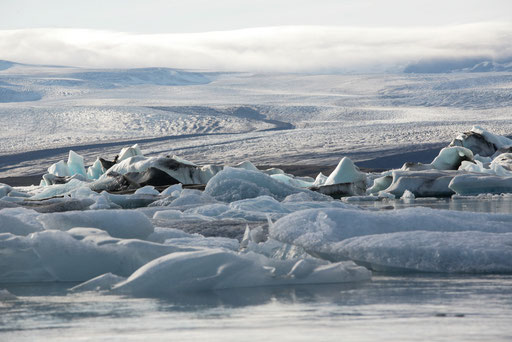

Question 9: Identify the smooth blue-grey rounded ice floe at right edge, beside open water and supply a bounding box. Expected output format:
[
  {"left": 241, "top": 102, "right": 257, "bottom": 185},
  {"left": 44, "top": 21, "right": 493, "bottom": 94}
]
[{"left": 336, "top": 231, "right": 512, "bottom": 273}]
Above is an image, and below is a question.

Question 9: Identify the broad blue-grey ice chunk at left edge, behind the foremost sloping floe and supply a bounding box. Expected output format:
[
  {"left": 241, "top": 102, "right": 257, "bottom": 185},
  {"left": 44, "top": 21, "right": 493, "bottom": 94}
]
[{"left": 0, "top": 228, "right": 193, "bottom": 283}]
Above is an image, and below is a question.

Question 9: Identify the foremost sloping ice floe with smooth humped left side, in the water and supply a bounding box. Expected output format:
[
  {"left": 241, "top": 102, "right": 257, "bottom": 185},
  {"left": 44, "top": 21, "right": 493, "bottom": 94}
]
[{"left": 114, "top": 249, "right": 371, "bottom": 297}]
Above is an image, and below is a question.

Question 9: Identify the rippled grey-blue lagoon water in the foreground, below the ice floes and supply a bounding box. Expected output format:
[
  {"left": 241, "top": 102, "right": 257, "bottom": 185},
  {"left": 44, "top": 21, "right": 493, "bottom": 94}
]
[{"left": 0, "top": 274, "right": 512, "bottom": 341}]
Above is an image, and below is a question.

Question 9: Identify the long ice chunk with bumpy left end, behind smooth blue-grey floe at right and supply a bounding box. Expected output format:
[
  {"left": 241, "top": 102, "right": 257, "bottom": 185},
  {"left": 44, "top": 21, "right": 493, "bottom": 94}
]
[{"left": 269, "top": 207, "right": 512, "bottom": 260}]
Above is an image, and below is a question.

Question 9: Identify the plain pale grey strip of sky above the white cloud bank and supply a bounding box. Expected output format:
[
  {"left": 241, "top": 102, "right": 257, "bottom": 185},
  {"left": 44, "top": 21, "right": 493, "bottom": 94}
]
[{"left": 0, "top": 0, "right": 512, "bottom": 33}]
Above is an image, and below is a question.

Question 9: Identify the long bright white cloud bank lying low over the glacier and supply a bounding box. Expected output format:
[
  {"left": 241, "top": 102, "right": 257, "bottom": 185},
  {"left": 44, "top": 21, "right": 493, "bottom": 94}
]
[{"left": 0, "top": 23, "right": 512, "bottom": 72}]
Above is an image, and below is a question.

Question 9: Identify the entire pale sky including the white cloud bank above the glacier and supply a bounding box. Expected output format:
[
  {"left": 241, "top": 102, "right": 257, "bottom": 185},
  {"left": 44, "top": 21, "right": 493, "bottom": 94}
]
[{"left": 0, "top": 0, "right": 512, "bottom": 72}]
